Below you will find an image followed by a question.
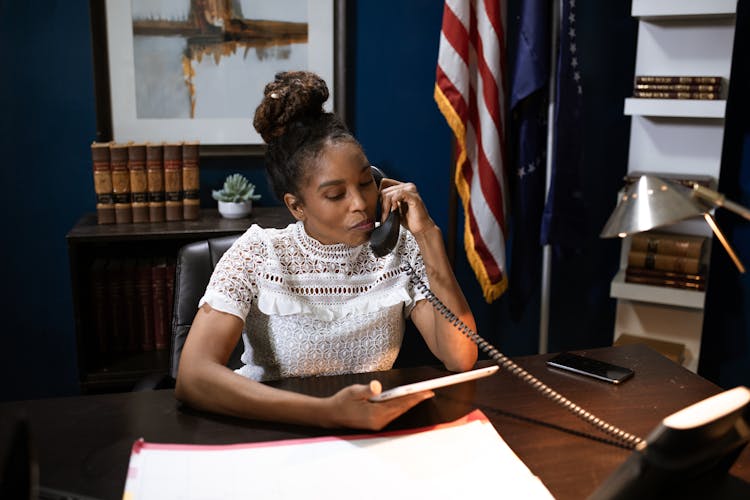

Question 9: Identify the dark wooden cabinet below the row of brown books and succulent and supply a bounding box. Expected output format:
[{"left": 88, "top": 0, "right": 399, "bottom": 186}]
[{"left": 66, "top": 207, "right": 293, "bottom": 393}]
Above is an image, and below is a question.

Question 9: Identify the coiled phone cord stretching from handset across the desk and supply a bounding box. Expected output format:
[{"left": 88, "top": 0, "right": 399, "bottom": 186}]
[{"left": 401, "top": 265, "right": 644, "bottom": 449}]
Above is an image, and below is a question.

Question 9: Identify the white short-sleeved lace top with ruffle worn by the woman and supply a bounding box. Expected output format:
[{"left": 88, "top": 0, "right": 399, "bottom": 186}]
[{"left": 199, "top": 222, "right": 428, "bottom": 380}]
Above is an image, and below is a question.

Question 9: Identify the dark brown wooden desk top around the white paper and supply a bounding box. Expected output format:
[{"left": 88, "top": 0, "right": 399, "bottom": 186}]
[{"left": 0, "top": 345, "right": 750, "bottom": 499}]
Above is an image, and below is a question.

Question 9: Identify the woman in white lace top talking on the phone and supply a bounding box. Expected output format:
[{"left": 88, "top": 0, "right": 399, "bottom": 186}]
[{"left": 176, "top": 72, "right": 477, "bottom": 430}]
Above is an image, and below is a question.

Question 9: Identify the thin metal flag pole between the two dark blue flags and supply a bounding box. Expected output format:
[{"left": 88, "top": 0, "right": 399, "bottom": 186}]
[{"left": 539, "top": 0, "right": 562, "bottom": 354}]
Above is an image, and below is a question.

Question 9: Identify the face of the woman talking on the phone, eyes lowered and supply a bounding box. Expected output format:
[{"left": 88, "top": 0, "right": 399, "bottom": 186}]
[{"left": 284, "top": 141, "right": 378, "bottom": 246}]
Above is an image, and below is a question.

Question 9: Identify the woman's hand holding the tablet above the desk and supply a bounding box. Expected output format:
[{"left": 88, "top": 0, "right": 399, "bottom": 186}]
[{"left": 326, "top": 380, "right": 435, "bottom": 431}]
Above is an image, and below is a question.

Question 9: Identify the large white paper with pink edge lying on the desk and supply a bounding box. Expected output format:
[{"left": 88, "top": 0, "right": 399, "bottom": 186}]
[{"left": 123, "top": 410, "right": 553, "bottom": 500}]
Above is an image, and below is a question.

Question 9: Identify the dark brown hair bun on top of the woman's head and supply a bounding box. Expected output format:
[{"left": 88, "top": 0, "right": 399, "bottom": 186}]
[{"left": 253, "top": 71, "right": 328, "bottom": 143}]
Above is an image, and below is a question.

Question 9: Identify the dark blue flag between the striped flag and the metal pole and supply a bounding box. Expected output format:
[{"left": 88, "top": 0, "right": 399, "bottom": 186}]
[{"left": 508, "top": 0, "right": 550, "bottom": 320}]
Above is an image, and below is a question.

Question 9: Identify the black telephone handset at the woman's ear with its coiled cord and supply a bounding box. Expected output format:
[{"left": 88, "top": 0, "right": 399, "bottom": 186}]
[{"left": 370, "top": 166, "right": 643, "bottom": 448}]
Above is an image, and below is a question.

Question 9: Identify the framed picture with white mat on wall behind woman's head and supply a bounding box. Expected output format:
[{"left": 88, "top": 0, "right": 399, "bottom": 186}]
[{"left": 89, "top": 0, "right": 347, "bottom": 156}]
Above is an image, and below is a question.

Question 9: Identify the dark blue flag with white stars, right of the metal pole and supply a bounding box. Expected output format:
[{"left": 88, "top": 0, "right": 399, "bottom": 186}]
[{"left": 541, "top": 0, "right": 586, "bottom": 248}]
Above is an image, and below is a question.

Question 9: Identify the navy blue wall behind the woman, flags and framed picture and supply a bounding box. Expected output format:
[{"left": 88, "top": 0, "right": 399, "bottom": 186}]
[{"left": 10, "top": 0, "right": 724, "bottom": 400}]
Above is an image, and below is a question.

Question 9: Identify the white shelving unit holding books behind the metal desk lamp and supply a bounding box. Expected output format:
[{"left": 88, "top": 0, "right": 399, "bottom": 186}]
[{"left": 610, "top": 0, "right": 736, "bottom": 372}]
